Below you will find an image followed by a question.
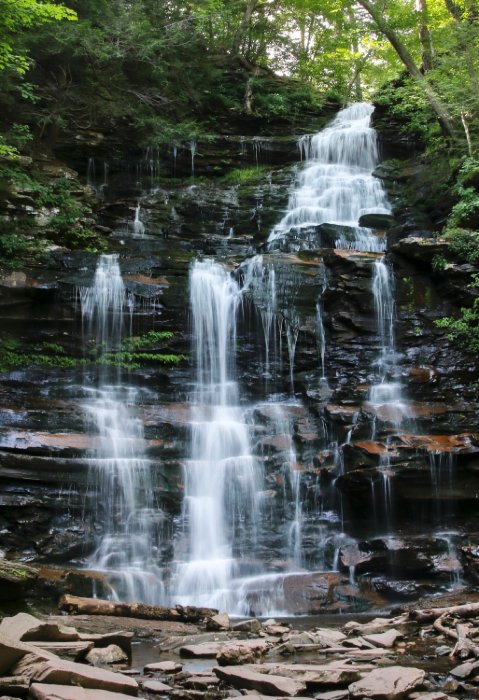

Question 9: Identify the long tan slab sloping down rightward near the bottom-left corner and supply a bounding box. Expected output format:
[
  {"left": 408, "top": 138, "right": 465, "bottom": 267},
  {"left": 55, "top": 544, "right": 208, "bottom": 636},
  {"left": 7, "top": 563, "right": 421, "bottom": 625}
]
[{"left": 11, "top": 652, "right": 138, "bottom": 695}]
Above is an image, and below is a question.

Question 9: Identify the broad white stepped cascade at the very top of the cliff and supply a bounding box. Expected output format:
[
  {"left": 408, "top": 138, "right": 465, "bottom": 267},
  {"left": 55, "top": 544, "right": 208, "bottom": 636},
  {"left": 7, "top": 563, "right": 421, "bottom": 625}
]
[{"left": 268, "top": 103, "right": 390, "bottom": 252}]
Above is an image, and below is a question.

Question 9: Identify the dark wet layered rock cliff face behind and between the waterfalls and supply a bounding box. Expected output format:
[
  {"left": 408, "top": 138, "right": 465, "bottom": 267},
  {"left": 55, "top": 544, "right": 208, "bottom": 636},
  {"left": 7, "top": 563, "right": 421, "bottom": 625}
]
[{"left": 0, "top": 98, "right": 479, "bottom": 612}]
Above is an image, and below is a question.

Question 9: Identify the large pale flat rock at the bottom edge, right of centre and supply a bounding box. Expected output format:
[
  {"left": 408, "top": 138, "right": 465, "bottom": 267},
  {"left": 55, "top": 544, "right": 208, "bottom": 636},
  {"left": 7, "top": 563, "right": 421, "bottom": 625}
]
[{"left": 348, "top": 666, "right": 426, "bottom": 700}]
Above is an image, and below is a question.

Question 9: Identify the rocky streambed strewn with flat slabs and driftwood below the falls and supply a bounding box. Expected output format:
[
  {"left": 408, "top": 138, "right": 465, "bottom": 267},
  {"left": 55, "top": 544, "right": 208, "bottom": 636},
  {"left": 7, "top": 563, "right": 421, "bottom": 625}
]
[{"left": 0, "top": 596, "right": 479, "bottom": 700}]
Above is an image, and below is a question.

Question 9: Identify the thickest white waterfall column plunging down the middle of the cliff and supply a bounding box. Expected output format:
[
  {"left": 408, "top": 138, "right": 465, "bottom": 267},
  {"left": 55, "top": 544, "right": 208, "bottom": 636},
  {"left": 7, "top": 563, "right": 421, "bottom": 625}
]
[{"left": 174, "top": 260, "right": 262, "bottom": 610}]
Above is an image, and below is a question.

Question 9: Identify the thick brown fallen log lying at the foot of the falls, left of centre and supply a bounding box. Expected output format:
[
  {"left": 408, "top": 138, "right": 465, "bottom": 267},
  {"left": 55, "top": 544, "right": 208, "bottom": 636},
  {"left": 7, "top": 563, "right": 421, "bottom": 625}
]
[{"left": 58, "top": 595, "right": 218, "bottom": 622}]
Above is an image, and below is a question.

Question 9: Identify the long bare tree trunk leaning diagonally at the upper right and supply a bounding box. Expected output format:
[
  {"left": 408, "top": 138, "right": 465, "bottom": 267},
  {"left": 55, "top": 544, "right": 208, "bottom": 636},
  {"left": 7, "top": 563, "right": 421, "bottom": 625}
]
[{"left": 357, "top": 0, "right": 454, "bottom": 139}]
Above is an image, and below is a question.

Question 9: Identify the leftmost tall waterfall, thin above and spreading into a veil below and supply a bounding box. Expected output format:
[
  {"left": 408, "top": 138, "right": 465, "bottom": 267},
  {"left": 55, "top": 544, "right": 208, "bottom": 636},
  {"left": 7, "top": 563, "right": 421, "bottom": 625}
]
[{"left": 80, "top": 255, "right": 164, "bottom": 603}]
